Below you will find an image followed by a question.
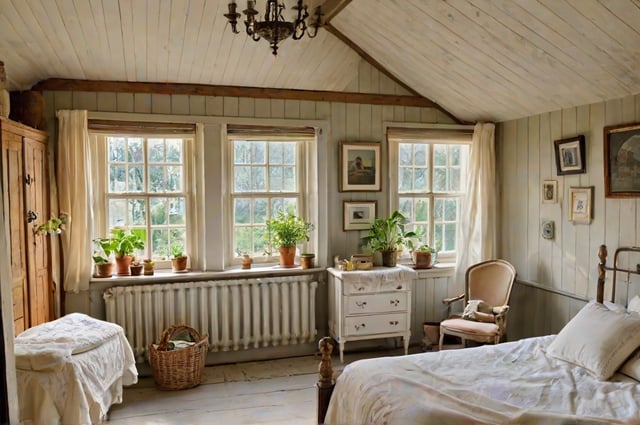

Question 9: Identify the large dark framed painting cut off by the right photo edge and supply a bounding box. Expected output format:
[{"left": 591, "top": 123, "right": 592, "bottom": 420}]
[{"left": 604, "top": 123, "right": 640, "bottom": 198}]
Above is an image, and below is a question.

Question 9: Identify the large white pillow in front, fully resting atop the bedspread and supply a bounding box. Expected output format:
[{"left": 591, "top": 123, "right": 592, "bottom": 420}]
[{"left": 547, "top": 303, "right": 640, "bottom": 380}]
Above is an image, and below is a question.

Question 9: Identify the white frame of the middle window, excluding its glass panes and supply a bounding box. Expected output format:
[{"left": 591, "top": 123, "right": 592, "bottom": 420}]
[{"left": 223, "top": 129, "right": 318, "bottom": 266}]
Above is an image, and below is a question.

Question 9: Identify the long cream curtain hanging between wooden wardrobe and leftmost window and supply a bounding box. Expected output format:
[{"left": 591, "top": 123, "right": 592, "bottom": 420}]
[{"left": 56, "top": 110, "right": 92, "bottom": 293}]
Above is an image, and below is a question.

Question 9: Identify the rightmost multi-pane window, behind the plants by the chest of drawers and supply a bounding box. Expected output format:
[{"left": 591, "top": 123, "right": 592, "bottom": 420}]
[{"left": 389, "top": 129, "right": 471, "bottom": 258}]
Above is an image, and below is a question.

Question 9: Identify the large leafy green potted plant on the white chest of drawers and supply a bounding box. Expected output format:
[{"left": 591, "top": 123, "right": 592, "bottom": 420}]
[{"left": 364, "top": 211, "right": 416, "bottom": 267}]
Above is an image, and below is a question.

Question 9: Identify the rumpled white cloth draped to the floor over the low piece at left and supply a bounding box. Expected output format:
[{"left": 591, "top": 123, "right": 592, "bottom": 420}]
[{"left": 15, "top": 313, "right": 138, "bottom": 425}]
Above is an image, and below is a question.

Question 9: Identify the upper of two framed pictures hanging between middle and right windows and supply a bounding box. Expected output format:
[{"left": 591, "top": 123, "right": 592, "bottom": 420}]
[{"left": 340, "top": 142, "right": 380, "bottom": 192}]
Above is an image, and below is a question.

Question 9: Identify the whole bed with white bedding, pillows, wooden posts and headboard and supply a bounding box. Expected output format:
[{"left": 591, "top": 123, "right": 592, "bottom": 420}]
[{"left": 318, "top": 246, "right": 640, "bottom": 425}]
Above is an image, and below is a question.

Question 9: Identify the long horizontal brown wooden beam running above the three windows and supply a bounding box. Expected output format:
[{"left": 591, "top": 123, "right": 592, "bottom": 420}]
[{"left": 32, "top": 78, "right": 438, "bottom": 107}]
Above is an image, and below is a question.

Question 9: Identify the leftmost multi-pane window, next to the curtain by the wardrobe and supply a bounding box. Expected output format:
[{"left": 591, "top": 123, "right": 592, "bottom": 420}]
[{"left": 90, "top": 121, "right": 193, "bottom": 261}]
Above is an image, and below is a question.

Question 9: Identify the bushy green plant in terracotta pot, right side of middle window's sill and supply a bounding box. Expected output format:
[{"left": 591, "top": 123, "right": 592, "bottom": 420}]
[{"left": 267, "top": 212, "right": 314, "bottom": 267}]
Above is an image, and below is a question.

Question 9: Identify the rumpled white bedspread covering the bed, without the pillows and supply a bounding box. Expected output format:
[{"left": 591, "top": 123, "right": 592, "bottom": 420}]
[{"left": 325, "top": 336, "right": 640, "bottom": 425}]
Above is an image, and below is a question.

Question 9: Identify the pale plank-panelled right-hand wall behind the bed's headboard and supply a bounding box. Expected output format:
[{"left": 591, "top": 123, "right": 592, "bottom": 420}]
[{"left": 496, "top": 94, "right": 640, "bottom": 336}]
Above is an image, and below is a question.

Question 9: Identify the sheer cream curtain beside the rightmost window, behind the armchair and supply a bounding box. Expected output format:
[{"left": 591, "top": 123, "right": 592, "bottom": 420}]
[{"left": 456, "top": 123, "right": 498, "bottom": 282}]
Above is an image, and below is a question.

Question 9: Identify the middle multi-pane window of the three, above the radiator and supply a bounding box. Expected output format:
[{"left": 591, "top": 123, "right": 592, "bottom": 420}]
[{"left": 228, "top": 127, "right": 313, "bottom": 262}]
